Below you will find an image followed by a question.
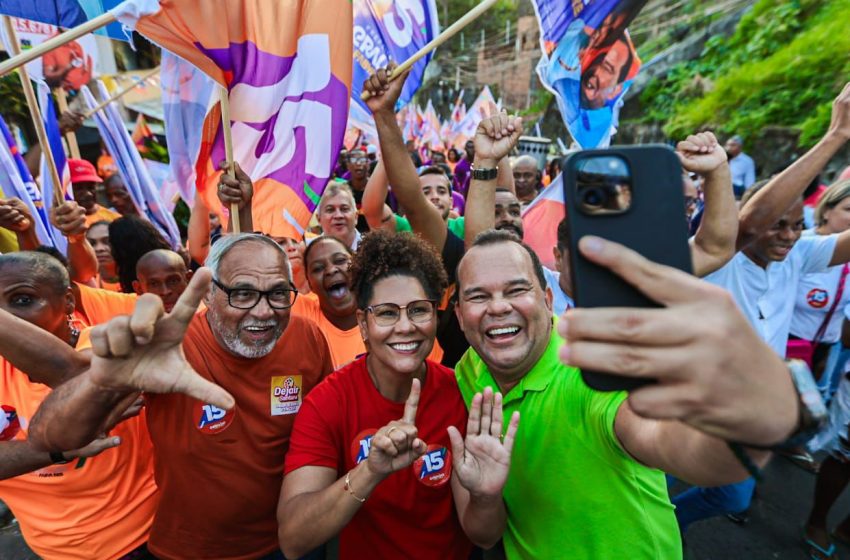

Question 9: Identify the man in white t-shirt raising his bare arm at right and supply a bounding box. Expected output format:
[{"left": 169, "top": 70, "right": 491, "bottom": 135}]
[{"left": 672, "top": 84, "right": 850, "bottom": 533}]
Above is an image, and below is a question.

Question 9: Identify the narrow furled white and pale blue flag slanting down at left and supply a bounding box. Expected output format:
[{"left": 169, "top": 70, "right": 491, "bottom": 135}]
[{"left": 80, "top": 80, "right": 180, "bottom": 249}]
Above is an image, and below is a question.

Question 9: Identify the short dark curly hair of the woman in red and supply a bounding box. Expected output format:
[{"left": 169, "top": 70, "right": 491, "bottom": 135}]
[{"left": 351, "top": 230, "right": 449, "bottom": 309}]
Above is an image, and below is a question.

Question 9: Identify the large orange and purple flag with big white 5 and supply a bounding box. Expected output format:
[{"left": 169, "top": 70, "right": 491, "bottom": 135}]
[{"left": 113, "top": 0, "right": 352, "bottom": 238}]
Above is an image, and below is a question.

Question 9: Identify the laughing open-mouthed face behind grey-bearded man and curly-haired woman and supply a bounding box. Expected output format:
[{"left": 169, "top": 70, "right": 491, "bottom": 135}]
[{"left": 306, "top": 237, "right": 357, "bottom": 317}]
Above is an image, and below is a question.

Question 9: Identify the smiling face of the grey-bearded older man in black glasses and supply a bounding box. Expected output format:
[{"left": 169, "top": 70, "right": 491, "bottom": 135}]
[{"left": 206, "top": 240, "right": 292, "bottom": 358}]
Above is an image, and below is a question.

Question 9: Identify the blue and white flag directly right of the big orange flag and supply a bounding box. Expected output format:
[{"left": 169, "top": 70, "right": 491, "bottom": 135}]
[{"left": 351, "top": 0, "right": 440, "bottom": 115}]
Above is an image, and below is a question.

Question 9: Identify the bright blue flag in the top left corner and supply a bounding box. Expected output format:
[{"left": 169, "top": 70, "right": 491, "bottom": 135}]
[{"left": 0, "top": 0, "right": 129, "bottom": 41}]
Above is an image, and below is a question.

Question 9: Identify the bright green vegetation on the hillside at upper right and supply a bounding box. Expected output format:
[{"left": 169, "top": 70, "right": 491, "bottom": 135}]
[{"left": 641, "top": 0, "right": 850, "bottom": 147}]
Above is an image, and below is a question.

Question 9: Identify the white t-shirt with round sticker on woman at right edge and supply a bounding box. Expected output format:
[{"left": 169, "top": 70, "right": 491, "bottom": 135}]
[{"left": 791, "top": 230, "right": 850, "bottom": 344}]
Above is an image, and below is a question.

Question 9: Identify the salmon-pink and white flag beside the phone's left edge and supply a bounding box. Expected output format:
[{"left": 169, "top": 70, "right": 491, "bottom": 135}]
[{"left": 522, "top": 175, "right": 566, "bottom": 269}]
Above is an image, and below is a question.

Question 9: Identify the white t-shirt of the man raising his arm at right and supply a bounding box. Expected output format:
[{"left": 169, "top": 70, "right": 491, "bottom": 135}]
[{"left": 705, "top": 234, "right": 838, "bottom": 357}]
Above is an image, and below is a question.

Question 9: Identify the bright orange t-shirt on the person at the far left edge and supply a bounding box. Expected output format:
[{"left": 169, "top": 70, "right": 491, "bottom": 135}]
[{"left": 0, "top": 358, "right": 158, "bottom": 560}]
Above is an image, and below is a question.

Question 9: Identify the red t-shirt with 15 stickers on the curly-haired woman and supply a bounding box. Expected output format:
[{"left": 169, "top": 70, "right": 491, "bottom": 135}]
[{"left": 286, "top": 357, "right": 472, "bottom": 560}]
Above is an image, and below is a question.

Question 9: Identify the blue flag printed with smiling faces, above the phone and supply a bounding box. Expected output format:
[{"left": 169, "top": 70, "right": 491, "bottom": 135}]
[{"left": 532, "top": 0, "right": 647, "bottom": 149}]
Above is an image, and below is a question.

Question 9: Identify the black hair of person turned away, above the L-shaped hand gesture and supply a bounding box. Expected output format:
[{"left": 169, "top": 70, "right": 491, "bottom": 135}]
[{"left": 109, "top": 215, "right": 171, "bottom": 294}]
